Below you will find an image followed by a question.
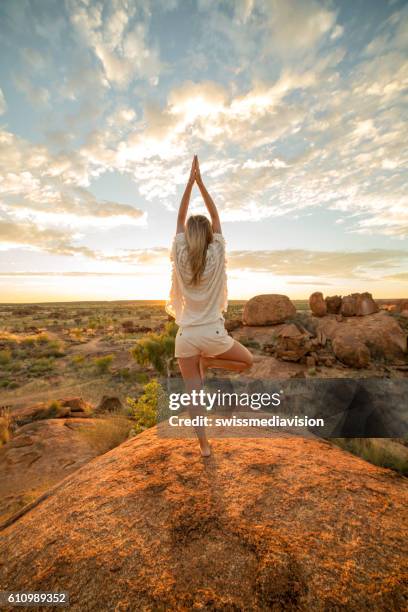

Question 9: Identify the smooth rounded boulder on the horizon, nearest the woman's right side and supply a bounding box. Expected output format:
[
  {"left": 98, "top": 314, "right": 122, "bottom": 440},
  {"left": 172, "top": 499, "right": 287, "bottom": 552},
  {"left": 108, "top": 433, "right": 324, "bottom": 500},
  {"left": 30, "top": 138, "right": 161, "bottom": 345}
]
[{"left": 242, "top": 293, "right": 296, "bottom": 325}]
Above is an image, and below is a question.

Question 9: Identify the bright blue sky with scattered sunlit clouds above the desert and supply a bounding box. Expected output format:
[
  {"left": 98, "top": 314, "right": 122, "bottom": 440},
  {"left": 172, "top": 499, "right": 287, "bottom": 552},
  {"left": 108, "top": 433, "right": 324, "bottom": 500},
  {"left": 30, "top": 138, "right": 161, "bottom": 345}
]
[{"left": 0, "top": 0, "right": 408, "bottom": 302}]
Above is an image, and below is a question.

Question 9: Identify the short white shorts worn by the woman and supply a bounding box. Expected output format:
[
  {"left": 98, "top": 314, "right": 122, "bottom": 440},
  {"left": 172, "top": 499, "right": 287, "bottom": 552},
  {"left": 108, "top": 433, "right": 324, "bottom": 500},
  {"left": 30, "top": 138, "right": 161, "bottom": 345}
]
[{"left": 174, "top": 320, "right": 234, "bottom": 358}]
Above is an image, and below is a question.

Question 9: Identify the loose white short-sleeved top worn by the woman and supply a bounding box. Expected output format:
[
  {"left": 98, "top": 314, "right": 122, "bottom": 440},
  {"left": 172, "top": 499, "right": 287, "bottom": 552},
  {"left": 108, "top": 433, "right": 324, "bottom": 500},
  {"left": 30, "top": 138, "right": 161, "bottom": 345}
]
[{"left": 165, "top": 232, "right": 228, "bottom": 326}]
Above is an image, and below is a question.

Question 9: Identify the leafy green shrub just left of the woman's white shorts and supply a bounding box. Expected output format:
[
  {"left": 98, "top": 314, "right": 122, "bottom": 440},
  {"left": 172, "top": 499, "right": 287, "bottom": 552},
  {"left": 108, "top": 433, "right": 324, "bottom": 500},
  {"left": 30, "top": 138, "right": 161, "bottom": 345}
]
[{"left": 131, "top": 321, "right": 178, "bottom": 376}]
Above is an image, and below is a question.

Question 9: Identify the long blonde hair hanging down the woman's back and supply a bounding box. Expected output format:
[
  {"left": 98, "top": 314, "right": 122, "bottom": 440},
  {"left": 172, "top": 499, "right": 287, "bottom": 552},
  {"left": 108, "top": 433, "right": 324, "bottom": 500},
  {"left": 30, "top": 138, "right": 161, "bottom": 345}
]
[{"left": 185, "top": 215, "right": 213, "bottom": 285}]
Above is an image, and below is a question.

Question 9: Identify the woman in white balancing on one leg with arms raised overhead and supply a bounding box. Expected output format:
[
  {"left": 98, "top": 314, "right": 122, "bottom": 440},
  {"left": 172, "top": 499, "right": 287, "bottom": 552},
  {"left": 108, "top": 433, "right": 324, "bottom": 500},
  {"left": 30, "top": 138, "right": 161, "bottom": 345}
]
[{"left": 166, "top": 155, "right": 253, "bottom": 457}]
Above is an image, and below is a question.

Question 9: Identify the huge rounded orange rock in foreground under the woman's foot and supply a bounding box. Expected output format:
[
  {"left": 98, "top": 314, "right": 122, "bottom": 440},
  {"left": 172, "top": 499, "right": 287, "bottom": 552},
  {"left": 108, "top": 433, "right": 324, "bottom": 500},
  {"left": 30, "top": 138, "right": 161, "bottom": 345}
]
[{"left": 0, "top": 428, "right": 408, "bottom": 612}]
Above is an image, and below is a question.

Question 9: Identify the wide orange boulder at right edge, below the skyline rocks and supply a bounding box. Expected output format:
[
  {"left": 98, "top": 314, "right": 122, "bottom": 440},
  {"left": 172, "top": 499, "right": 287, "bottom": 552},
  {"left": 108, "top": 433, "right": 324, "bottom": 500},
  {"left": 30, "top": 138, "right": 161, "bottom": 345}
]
[{"left": 318, "top": 311, "right": 407, "bottom": 367}]
